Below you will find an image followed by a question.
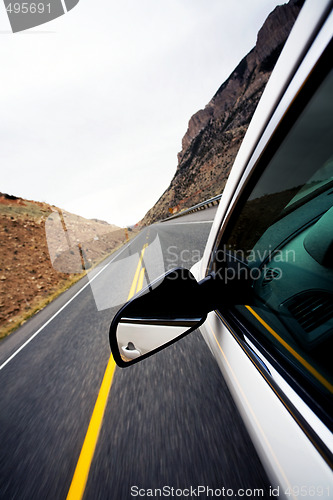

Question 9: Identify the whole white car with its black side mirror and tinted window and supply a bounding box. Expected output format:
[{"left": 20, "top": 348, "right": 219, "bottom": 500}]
[{"left": 110, "top": 0, "right": 333, "bottom": 498}]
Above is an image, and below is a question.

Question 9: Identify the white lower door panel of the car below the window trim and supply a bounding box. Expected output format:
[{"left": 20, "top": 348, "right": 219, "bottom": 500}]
[{"left": 201, "top": 312, "right": 333, "bottom": 498}]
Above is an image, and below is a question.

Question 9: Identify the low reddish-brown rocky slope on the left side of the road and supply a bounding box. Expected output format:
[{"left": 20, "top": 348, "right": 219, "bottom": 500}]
[{"left": 0, "top": 193, "right": 128, "bottom": 338}]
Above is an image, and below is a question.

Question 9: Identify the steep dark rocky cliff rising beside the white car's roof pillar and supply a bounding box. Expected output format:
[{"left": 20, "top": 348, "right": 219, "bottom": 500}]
[{"left": 142, "top": 0, "right": 304, "bottom": 224}]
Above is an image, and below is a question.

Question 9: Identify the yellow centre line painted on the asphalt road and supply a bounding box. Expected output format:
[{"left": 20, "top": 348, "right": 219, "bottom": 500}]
[{"left": 67, "top": 243, "right": 148, "bottom": 500}]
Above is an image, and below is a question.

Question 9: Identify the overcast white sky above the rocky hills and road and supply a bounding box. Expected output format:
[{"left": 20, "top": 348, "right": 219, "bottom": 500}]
[{"left": 0, "top": 0, "right": 285, "bottom": 226}]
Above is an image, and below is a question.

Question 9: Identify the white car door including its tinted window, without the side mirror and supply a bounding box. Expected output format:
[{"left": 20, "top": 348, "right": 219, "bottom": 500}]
[{"left": 197, "top": 7, "right": 333, "bottom": 498}]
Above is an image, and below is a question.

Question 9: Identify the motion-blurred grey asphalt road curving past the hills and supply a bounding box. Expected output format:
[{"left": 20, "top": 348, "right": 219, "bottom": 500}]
[{"left": 0, "top": 209, "right": 269, "bottom": 500}]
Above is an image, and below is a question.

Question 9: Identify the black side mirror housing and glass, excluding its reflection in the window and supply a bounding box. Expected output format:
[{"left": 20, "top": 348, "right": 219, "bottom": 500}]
[{"left": 110, "top": 268, "right": 207, "bottom": 367}]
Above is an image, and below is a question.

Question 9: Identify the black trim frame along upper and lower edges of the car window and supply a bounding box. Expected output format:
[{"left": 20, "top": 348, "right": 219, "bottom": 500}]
[{"left": 207, "top": 40, "right": 333, "bottom": 434}]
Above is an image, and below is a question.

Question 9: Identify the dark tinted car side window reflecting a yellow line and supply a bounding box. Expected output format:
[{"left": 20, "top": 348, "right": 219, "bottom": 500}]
[{"left": 215, "top": 65, "right": 333, "bottom": 418}]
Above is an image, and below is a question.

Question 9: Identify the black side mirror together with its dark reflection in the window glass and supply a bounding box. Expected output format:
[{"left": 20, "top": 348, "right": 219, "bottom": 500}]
[{"left": 109, "top": 255, "right": 252, "bottom": 367}]
